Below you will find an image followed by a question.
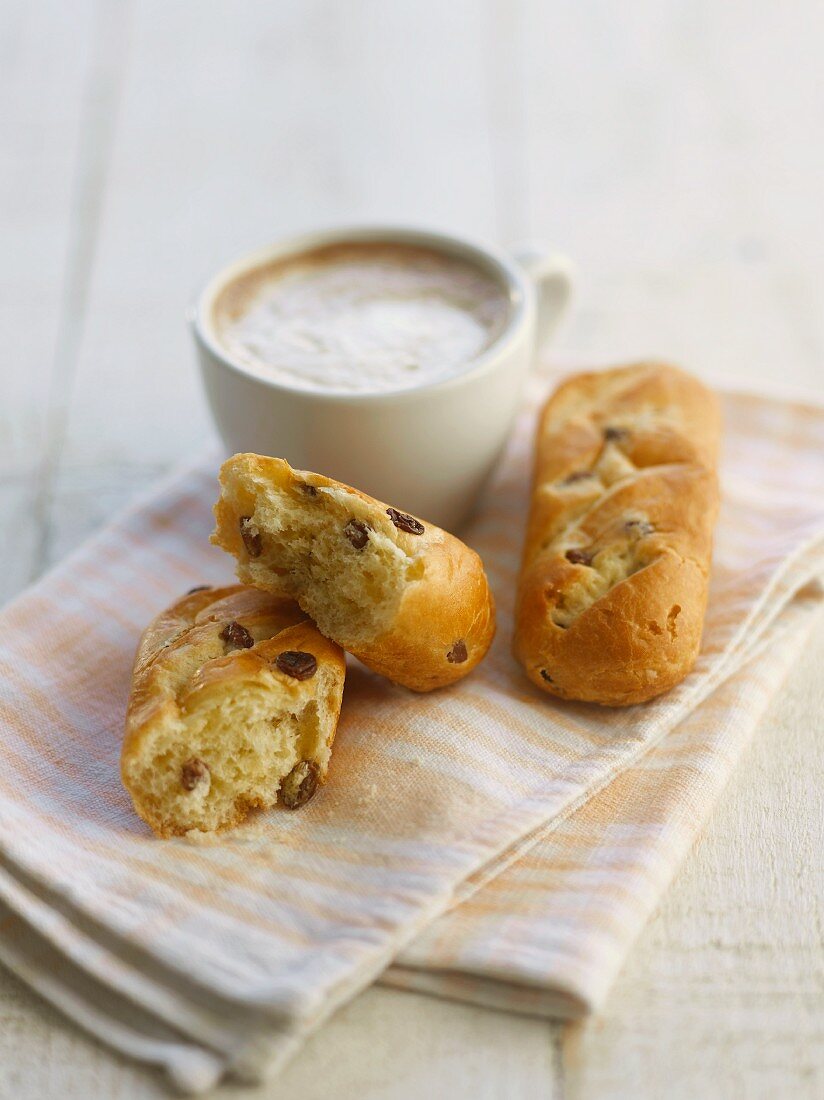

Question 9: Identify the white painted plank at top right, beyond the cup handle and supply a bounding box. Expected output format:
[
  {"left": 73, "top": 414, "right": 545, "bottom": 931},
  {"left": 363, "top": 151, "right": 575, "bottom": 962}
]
[{"left": 517, "top": 0, "right": 824, "bottom": 394}]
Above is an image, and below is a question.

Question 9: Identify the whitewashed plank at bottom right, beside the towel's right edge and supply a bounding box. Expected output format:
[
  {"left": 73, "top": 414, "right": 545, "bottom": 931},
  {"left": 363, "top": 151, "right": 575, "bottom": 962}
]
[{"left": 563, "top": 622, "right": 824, "bottom": 1100}]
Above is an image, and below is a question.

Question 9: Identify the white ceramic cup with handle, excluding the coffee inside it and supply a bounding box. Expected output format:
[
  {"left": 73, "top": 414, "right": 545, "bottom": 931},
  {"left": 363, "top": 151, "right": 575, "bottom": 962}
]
[{"left": 189, "top": 227, "right": 571, "bottom": 530}]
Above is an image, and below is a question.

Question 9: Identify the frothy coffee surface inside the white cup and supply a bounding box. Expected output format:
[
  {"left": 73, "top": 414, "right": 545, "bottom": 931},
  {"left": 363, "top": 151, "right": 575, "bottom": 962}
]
[{"left": 212, "top": 242, "right": 510, "bottom": 393}]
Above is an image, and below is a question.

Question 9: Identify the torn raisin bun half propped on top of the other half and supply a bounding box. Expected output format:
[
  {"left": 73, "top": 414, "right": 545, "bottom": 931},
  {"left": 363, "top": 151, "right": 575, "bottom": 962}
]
[{"left": 212, "top": 454, "right": 495, "bottom": 691}]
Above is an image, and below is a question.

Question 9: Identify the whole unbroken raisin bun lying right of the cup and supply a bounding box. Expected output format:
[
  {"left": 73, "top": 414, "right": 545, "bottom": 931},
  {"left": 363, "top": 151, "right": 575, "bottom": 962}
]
[{"left": 514, "top": 363, "right": 719, "bottom": 706}]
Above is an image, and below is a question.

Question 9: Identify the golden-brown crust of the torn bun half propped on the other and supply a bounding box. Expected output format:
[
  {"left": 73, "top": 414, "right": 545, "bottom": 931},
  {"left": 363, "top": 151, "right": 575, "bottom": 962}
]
[{"left": 212, "top": 454, "right": 495, "bottom": 691}]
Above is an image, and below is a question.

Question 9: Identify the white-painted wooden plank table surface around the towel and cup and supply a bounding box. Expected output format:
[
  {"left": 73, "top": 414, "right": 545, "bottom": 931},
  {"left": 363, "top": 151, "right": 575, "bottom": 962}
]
[{"left": 0, "top": 0, "right": 824, "bottom": 1100}]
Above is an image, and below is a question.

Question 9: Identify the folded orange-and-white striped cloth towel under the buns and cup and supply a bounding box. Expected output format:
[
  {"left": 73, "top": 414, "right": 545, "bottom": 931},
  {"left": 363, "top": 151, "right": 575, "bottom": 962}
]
[{"left": 0, "top": 382, "right": 824, "bottom": 1091}]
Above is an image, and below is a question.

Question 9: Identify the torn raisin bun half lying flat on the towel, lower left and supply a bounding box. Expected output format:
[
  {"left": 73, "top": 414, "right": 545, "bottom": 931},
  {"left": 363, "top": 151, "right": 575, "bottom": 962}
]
[{"left": 121, "top": 585, "right": 345, "bottom": 837}]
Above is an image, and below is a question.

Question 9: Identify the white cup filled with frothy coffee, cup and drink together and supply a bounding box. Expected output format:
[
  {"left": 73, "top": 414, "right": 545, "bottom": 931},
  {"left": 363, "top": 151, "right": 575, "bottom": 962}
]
[{"left": 189, "top": 227, "right": 570, "bottom": 530}]
